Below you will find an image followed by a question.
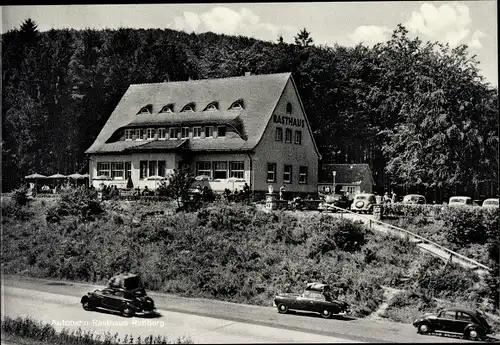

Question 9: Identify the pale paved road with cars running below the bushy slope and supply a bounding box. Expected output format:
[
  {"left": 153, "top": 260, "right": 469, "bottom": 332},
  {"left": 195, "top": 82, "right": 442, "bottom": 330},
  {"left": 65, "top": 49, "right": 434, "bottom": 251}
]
[{"left": 1, "top": 277, "right": 476, "bottom": 343}]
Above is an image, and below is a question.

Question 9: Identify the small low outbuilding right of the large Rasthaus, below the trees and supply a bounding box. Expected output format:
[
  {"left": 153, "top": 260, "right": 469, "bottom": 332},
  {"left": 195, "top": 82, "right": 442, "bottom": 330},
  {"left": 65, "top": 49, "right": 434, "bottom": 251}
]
[{"left": 318, "top": 164, "right": 375, "bottom": 199}]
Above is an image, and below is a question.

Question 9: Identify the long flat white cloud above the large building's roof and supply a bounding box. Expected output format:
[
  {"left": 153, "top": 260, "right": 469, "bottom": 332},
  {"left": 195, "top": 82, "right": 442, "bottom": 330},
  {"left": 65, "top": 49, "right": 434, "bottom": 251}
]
[{"left": 174, "top": 6, "right": 298, "bottom": 42}]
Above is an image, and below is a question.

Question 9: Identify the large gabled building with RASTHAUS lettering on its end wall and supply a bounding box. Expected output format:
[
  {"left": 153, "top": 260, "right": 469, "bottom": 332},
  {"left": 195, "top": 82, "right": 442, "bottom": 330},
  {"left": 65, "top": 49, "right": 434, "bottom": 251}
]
[{"left": 86, "top": 73, "right": 320, "bottom": 194}]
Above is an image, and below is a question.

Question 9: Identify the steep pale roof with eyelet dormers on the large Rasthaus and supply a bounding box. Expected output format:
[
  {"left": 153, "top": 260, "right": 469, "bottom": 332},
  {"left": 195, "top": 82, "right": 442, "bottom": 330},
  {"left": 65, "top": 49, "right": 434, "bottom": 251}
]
[{"left": 86, "top": 73, "right": 291, "bottom": 153}]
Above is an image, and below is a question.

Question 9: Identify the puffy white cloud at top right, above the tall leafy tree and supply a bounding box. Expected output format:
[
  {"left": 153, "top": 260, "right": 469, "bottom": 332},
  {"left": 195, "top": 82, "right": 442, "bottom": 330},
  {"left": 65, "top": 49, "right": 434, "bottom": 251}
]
[{"left": 404, "top": 2, "right": 481, "bottom": 48}]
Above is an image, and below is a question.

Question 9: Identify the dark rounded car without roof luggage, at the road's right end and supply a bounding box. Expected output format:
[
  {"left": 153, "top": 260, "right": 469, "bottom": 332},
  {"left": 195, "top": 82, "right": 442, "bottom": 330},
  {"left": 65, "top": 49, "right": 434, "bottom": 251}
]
[{"left": 413, "top": 308, "right": 493, "bottom": 340}]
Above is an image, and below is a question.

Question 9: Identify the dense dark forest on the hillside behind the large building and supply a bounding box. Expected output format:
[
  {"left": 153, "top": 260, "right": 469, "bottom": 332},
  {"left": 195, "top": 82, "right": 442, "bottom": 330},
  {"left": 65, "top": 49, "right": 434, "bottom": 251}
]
[{"left": 2, "top": 20, "right": 498, "bottom": 200}]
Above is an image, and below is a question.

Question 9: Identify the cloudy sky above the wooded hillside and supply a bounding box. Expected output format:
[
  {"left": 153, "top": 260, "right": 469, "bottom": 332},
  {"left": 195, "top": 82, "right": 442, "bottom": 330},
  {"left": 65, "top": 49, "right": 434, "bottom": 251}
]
[{"left": 1, "top": 0, "right": 498, "bottom": 86}]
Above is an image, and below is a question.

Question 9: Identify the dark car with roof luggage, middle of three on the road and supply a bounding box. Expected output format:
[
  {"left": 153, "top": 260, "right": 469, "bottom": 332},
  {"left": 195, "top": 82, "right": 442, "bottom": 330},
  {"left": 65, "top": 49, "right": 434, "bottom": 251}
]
[{"left": 273, "top": 282, "right": 350, "bottom": 319}]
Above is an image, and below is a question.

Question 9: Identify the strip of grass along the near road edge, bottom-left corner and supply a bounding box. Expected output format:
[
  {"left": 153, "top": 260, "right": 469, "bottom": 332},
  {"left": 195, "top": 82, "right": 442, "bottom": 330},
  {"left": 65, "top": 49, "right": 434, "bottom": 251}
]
[{"left": 1, "top": 316, "right": 193, "bottom": 345}]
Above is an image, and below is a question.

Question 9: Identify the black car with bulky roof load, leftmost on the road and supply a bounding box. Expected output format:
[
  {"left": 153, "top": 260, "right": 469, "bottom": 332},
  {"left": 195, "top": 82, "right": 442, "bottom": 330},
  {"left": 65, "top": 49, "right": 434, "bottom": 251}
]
[{"left": 80, "top": 274, "right": 156, "bottom": 317}]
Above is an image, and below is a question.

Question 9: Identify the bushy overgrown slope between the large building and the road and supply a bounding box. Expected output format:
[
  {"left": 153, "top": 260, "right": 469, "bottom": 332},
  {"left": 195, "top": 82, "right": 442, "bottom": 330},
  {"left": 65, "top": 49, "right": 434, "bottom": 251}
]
[{"left": 2, "top": 191, "right": 498, "bottom": 317}]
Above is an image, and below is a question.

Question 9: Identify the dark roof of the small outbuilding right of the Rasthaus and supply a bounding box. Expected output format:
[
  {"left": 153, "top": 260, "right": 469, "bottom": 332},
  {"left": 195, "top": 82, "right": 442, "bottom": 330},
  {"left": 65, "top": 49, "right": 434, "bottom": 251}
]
[{"left": 318, "top": 164, "right": 371, "bottom": 184}]
